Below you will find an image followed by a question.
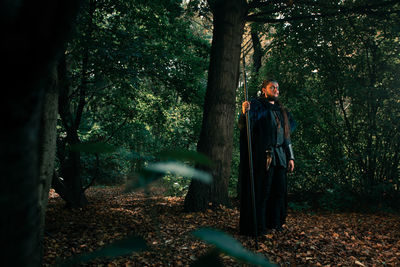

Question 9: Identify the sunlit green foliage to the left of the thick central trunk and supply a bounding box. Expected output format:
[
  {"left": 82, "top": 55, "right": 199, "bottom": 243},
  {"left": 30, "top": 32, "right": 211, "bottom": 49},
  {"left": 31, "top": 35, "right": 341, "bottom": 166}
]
[{"left": 58, "top": 0, "right": 209, "bottom": 189}]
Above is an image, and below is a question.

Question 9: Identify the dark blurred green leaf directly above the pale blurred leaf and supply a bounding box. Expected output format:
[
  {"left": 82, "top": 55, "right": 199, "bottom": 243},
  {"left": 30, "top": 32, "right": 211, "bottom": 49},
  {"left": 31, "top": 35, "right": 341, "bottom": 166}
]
[{"left": 155, "top": 150, "right": 213, "bottom": 166}]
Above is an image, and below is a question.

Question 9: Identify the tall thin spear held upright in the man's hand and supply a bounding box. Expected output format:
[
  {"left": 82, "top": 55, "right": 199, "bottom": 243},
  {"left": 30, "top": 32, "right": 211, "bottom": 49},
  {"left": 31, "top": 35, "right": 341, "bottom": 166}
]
[{"left": 243, "top": 51, "right": 258, "bottom": 250}]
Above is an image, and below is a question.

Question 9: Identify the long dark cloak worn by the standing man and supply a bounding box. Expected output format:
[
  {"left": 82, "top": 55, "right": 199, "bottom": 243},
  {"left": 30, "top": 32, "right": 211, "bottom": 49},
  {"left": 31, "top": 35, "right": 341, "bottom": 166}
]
[{"left": 239, "top": 97, "right": 295, "bottom": 235}]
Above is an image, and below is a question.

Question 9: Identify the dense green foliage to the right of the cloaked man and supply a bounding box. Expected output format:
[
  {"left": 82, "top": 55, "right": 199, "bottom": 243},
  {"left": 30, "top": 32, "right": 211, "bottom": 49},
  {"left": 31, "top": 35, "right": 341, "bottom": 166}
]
[{"left": 248, "top": 1, "right": 400, "bottom": 213}]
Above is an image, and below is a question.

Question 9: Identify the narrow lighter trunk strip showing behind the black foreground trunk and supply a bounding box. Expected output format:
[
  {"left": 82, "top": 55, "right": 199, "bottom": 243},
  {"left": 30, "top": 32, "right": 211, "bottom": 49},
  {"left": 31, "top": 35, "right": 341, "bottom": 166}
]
[{"left": 38, "top": 63, "right": 58, "bottom": 260}]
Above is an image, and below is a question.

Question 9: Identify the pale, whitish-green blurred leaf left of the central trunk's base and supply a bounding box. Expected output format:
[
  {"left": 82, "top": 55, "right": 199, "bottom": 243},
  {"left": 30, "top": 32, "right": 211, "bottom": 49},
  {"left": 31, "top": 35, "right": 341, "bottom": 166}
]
[{"left": 146, "top": 161, "right": 212, "bottom": 183}]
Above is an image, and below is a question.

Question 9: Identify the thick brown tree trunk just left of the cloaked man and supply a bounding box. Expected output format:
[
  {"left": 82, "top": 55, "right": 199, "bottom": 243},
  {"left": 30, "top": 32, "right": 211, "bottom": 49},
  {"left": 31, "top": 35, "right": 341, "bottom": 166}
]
[{"left": 185, "top": 0, "right": 247, "bottom": 211}]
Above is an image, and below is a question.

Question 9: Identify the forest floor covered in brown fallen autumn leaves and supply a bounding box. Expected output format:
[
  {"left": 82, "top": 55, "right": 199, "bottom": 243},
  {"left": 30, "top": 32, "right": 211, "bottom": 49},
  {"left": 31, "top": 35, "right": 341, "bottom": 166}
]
[{"left": 44, "top": 187, "right": 400, "bottom": 267}]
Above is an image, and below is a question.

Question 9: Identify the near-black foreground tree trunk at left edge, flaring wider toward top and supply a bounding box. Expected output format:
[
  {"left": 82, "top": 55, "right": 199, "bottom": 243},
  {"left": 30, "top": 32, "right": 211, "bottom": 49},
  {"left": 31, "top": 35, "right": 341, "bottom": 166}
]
[{"left": 0, "top": 1, "right": 79, "bottom": 266}]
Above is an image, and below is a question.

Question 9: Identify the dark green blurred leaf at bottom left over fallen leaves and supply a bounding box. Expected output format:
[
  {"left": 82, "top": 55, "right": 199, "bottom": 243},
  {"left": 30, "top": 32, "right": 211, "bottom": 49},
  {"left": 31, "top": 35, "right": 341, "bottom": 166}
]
[{"left": 62, "top": 236, "right": 147, "bottom": 266}]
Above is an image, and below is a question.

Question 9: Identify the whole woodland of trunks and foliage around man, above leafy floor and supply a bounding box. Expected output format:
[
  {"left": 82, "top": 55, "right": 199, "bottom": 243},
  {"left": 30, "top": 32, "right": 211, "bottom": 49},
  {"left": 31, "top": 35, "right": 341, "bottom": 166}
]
[{"left": 0, "top": 0, "right": 400, "bottom": 266}]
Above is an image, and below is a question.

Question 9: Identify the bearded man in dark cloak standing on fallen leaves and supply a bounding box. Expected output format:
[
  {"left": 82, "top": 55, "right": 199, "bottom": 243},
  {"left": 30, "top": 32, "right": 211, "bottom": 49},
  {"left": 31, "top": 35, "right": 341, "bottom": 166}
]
[{"left": 239, "top": 80, "right": 294, "bottom": 235}]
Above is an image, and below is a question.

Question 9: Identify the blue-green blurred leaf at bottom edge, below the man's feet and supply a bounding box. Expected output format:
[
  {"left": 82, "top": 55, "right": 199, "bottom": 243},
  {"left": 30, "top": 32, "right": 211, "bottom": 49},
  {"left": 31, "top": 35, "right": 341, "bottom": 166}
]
[{"left": 193, "top": 228, "right": 276, "bottom": 267}]
